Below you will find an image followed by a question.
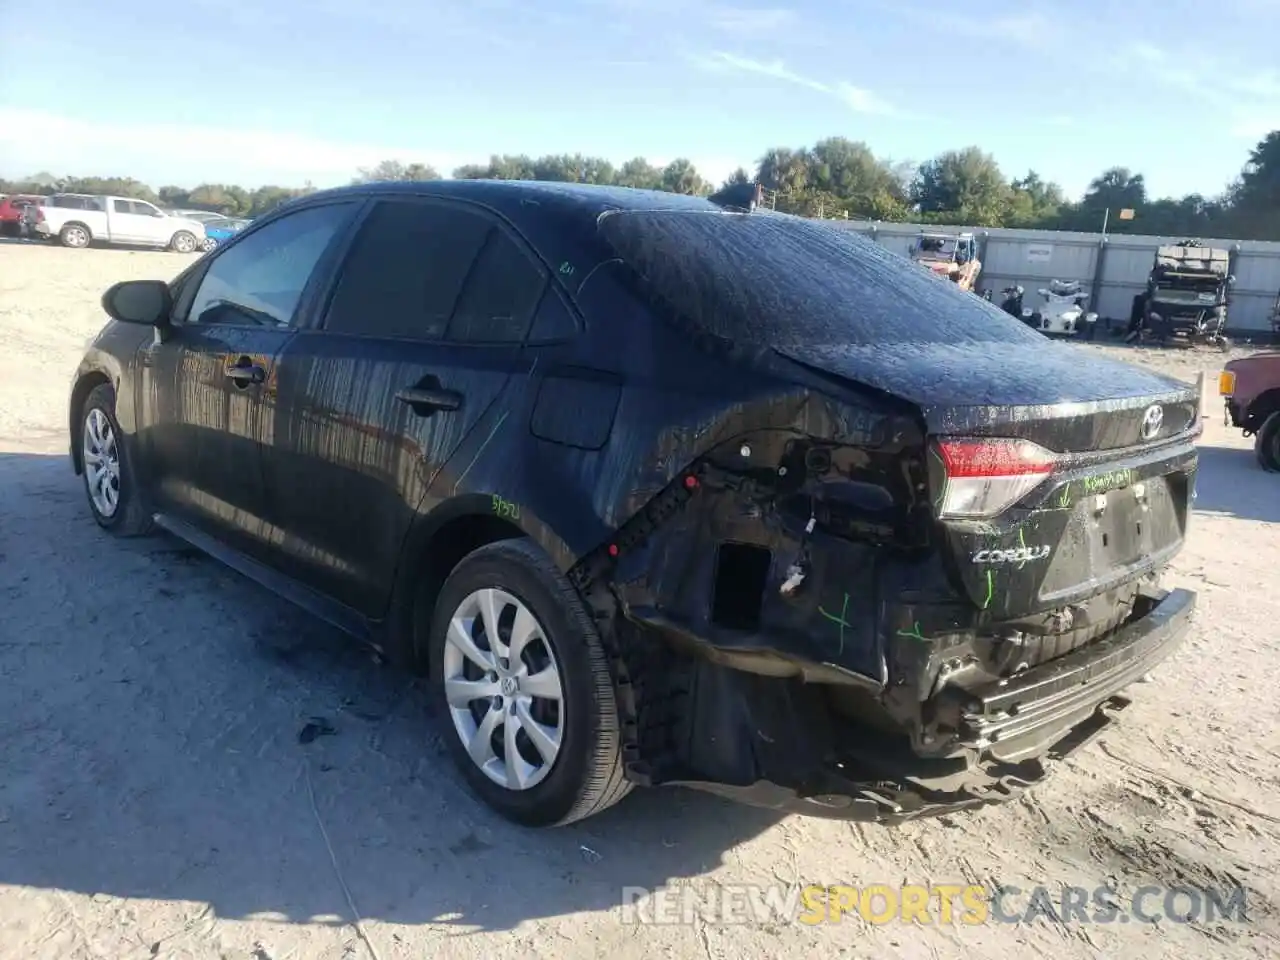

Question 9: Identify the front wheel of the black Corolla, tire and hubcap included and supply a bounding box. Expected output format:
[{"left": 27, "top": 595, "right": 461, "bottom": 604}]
[{"left": 79, "top": 384, "right": 151, "bottom": 536}]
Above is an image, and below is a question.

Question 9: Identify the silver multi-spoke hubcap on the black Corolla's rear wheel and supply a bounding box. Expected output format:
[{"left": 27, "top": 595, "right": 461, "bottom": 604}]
[{"left": 443, "top": 589, "right": 564, "bottom": 790}]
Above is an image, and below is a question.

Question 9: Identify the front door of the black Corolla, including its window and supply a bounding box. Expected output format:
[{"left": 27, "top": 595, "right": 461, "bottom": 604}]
[{"left": 137, "top": 204, "right": 355, "bottom": 558}]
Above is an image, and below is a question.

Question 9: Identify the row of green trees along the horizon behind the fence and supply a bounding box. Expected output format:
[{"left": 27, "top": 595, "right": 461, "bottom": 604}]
[{"left": 0, "top": 131, "right": 1280, "bottom": 241}]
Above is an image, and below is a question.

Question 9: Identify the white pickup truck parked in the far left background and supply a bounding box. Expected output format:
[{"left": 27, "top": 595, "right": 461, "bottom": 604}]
[{"left": 24, "top": 193, "right": 205, "bottom": 253}]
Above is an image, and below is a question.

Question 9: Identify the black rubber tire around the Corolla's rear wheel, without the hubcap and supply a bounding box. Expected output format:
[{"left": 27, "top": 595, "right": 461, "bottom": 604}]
[{"left": 429, "top": 539, "right": 632, "bottom": 827}]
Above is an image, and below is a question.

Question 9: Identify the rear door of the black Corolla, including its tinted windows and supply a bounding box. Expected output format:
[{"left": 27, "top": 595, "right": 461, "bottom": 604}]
[{"left": 264, "top": 198, "right": 548, "bottom": 617}]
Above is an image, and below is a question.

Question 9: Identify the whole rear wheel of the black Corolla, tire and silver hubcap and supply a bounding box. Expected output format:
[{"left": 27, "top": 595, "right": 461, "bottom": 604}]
[{"left": 430, "top": 539, "right": 631, "bottom": 827}]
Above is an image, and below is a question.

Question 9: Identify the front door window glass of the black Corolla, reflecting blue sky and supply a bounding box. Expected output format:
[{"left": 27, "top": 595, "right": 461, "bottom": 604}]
[{"left": 186, "top": 204, "right": 352, "bottom": 326}]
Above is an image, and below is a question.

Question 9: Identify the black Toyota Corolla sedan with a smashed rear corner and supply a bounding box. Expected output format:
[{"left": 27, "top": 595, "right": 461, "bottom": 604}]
[{"left": 69, "top": 180, "right": 1201, "bottom": 824}]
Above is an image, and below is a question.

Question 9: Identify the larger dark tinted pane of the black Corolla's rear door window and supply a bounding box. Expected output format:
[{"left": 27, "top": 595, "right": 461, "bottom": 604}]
[{"left": 325, "top": 200, "right": 492, "bottom": 339}]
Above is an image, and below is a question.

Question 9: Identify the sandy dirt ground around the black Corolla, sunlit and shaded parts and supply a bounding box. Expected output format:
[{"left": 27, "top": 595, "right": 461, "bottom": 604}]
[{"left": 0, "top": 243, "right": 1280, "bottom": 960}]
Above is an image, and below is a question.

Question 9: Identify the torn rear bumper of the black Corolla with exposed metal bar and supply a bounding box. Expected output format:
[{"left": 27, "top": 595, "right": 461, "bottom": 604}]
[{"left": 665, "top": 590, "right": 1196, "bottom": 823}]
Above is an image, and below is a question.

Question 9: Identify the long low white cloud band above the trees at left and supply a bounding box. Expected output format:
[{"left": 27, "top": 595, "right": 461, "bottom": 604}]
[{"left": 0, "top": 106, "right": 474, "bottom": 187}]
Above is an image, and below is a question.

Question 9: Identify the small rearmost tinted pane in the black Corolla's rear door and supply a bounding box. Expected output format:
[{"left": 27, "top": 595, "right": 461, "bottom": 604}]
[{"left": 447, "top": 227, "right": 547, "bottom": 343}]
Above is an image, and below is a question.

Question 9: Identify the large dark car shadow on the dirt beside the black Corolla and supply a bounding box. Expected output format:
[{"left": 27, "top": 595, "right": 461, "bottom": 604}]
[{"left": 0, "top": 453, "right": 777, "bottom": 932}]
